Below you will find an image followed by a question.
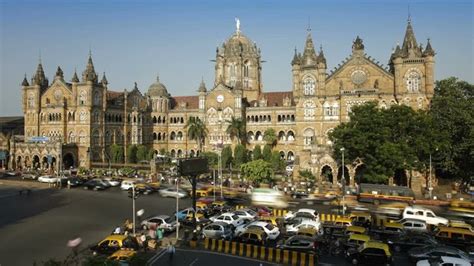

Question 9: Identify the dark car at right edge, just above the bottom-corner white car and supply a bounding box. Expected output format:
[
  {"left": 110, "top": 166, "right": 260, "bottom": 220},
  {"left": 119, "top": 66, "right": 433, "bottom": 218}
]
[{"left": 408, "top": 244, "right": 472, "bottom": 262}]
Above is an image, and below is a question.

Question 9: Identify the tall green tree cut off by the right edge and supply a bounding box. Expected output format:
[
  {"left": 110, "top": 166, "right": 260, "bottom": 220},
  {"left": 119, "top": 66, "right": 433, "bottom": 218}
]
[{"left": 429, "top": 77, "right": 474, "bottom": 180}]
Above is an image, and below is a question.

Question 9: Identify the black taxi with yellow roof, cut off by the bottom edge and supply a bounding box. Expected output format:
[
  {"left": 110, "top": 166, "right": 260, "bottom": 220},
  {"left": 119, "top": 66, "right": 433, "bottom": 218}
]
[{"left": 346, "top": 241, "right": 392, "bottom": 265}]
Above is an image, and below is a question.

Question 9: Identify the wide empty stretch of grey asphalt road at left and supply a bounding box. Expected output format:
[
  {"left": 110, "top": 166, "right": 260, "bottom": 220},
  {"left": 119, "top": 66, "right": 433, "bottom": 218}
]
[{"left": 0, "top": 185, "right": 190, "bottom": 265}]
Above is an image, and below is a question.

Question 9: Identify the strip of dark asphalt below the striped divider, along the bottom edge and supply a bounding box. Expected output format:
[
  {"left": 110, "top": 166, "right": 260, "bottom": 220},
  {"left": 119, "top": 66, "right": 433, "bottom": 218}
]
[{"left": 150, "top": 249, "right": 277, "bottom": 266}]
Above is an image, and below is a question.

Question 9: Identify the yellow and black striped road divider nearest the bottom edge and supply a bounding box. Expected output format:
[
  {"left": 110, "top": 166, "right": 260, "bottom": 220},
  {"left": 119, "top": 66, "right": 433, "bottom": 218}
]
[{"left": 204, "top": 238, "right": 317, "bottom": 266}]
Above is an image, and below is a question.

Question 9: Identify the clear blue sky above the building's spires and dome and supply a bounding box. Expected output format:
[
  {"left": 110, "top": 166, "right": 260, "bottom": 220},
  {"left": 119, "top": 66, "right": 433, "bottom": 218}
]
[{"left": 0, "top": 0, "right": 474, "bottom": 116}]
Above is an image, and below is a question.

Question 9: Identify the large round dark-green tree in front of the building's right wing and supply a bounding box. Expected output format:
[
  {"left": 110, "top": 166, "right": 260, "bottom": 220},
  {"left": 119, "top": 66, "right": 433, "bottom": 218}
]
[{"left": 330, "top": 102, "right": 438, "bottom": 183}]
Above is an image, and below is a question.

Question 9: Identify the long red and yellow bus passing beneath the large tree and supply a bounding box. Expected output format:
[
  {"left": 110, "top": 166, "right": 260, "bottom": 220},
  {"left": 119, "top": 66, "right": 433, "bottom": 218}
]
[{"left": 357, "top": 184, "right": 415, "bottom": 204}]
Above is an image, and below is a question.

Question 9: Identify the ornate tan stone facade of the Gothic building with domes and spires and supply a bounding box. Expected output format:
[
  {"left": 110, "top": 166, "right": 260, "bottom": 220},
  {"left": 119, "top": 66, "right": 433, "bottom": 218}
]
[{"left": 13, "top": 21, "right": 435, "bottom": 183}]
